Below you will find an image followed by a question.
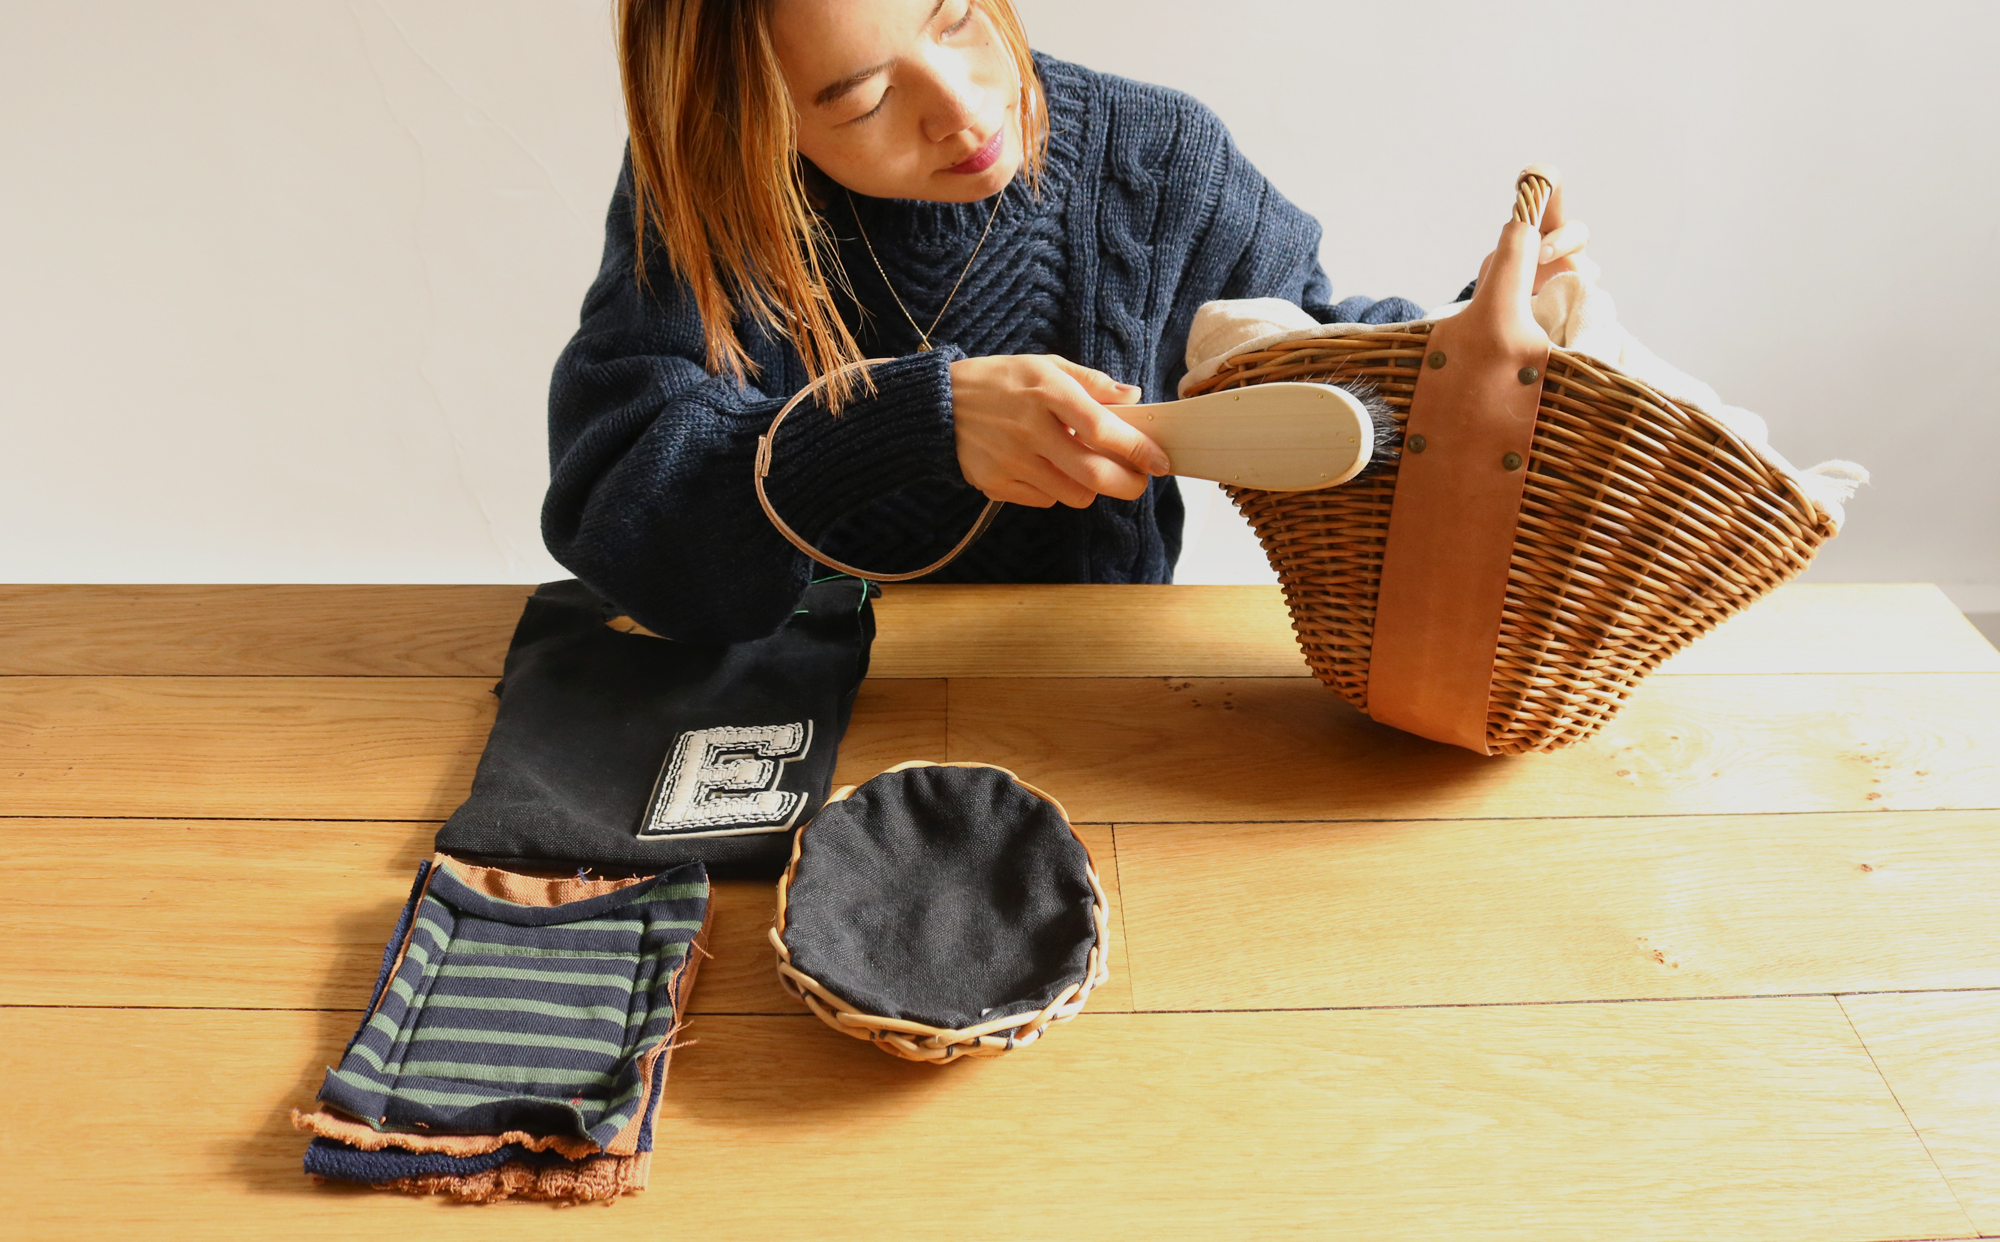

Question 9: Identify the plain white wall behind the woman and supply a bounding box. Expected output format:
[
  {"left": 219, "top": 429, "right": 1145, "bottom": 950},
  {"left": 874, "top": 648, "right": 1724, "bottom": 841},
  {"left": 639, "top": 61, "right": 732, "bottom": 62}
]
[{"left": 0, "top": 0, "right": 2000, "bottom": 610}]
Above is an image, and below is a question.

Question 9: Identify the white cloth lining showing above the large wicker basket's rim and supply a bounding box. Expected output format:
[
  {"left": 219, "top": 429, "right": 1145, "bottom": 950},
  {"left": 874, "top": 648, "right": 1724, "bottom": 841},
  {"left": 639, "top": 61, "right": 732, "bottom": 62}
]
[{"left": 1180, "top": 272, "right": 1868, "bottom": 530}]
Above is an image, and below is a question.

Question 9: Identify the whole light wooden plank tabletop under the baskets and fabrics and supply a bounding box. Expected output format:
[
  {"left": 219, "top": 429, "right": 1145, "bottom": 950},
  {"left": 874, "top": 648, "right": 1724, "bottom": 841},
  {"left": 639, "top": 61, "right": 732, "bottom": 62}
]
[{"left": 0, "top": 586, "right": 2000, "bottom": 1242}]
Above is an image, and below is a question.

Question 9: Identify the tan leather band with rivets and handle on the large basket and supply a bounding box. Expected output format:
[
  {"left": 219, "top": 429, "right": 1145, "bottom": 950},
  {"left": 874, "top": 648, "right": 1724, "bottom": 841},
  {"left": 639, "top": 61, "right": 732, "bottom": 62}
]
[{"left": 1368, "top": 168, "right": 1562, "bottom": 754}]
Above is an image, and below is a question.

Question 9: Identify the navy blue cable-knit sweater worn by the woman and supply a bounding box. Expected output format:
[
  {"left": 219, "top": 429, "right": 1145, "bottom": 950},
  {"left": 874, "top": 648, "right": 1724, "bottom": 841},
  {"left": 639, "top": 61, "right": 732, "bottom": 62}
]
[{"left": 542, "top": 56, "right": 1422, "bottom": 642}]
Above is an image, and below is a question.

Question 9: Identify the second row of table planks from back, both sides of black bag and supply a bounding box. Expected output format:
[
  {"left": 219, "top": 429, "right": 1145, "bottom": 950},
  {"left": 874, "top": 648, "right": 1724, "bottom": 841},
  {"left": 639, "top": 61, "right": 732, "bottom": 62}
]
[{"left": 11, "top": 674, "right": 2000, "bottom": 822}]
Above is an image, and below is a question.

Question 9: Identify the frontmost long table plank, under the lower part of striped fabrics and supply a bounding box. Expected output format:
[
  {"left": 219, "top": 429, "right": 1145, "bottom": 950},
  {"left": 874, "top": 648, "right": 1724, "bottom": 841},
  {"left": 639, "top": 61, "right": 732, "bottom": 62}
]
[{"left": 0, "top": 996, "right": 1974, "bottom": 1242}]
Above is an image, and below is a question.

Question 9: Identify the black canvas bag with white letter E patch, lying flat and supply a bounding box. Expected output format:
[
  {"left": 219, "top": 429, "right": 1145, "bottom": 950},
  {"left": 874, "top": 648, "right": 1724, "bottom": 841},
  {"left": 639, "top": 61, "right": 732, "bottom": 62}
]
[{"left": 436, "top": 578, "right": 880, "bottom": 878}]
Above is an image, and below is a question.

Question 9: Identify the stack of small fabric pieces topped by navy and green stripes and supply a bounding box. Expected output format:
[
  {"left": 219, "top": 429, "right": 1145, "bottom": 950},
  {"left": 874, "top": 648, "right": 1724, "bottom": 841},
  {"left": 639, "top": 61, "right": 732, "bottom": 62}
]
[{"left": 292, "top": 854, "right": 708, "bottom": 1202}]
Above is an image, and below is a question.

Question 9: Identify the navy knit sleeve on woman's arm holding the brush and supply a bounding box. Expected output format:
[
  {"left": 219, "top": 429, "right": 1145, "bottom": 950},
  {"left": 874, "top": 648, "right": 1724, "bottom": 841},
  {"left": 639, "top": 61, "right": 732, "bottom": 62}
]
[{"left": 542, "top": 157, "right": 960, "bottom": 642}]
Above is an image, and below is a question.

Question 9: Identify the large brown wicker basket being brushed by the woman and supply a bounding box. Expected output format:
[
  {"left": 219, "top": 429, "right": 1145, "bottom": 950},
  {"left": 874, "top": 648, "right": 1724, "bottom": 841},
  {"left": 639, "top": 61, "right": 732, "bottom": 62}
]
[{"left": 1190, "top": 168, "right": 1834, "bottom": 754}]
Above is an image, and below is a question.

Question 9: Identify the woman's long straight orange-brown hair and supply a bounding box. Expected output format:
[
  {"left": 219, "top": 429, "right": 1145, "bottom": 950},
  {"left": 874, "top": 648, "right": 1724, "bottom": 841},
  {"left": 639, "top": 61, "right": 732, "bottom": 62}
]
[{"left": 618, "top": 0, "right": 1048, "bottom": 408}]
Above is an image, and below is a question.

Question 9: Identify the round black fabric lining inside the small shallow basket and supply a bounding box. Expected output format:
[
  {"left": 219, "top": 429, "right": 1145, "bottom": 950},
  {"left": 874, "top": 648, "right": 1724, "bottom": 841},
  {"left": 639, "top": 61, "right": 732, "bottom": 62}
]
[{"left": 784, "top": 766, "right": 1096, "bottom": 1030}]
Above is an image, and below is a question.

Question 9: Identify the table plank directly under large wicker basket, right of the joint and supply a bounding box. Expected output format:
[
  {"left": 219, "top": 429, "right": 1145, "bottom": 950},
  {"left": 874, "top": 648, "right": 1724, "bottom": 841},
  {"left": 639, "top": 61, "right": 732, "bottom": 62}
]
[{"left": 950, "top": 674, "right": 2000, "bottom": 822}]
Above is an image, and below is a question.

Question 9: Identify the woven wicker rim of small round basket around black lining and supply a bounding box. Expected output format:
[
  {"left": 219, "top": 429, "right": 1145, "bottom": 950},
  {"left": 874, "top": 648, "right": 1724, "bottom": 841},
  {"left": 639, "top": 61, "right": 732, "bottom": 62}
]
[{"left": 770, "top": 760, "right": 1110, "bottom": 1066}]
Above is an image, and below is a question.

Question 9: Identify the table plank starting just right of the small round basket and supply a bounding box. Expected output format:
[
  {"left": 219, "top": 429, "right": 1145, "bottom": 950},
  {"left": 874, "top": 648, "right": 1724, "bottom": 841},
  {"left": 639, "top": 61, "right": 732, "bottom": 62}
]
[{"left": 1118, "top": 812, "right": 2000, "bottom": 1010}]
